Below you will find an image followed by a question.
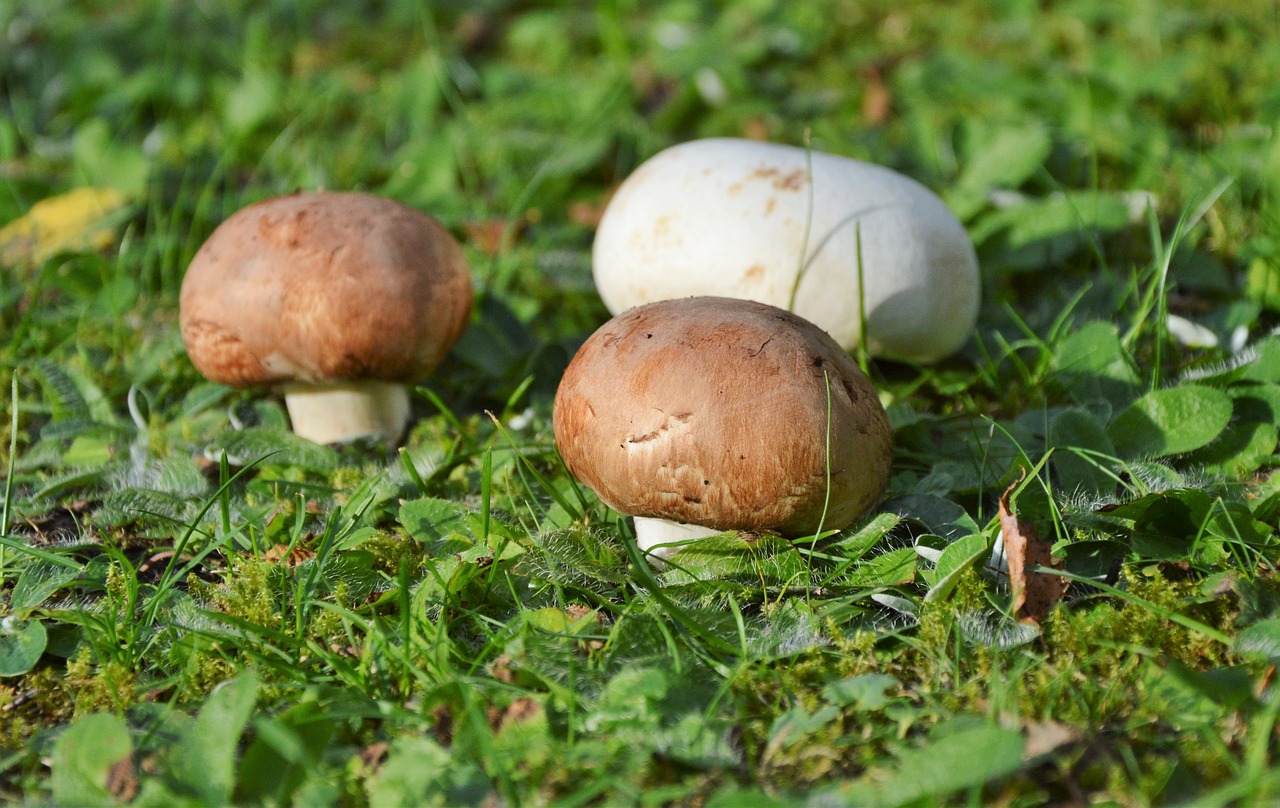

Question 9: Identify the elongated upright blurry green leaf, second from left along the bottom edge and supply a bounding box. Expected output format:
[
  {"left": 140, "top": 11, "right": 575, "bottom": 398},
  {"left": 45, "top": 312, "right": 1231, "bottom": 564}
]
[{"left": 169, "top": 671, "right": 257, "bottom": 805}]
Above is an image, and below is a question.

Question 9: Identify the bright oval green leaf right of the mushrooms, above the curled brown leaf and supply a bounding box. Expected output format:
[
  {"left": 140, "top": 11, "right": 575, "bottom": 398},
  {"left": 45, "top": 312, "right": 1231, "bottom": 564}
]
[{"left": 1107, "top": 384, "right": 1231, "bottom": 460}]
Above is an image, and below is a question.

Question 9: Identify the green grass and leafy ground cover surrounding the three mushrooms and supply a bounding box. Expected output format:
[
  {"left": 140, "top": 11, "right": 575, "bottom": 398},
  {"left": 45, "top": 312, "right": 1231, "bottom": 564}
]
[{"left": 0, "top": 0, "right": 1280, "bottom": 807}]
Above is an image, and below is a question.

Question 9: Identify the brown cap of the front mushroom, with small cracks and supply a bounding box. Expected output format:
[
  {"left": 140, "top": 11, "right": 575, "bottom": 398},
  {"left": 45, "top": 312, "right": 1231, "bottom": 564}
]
[{"left": 553, "top": 297, "right": 892, "bottom": 537}]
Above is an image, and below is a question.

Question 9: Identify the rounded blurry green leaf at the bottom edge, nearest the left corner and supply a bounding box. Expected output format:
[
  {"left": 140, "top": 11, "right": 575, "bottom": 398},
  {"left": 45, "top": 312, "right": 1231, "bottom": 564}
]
[{"left": 50, "top": 713, "right": 133, "bottom": 805}]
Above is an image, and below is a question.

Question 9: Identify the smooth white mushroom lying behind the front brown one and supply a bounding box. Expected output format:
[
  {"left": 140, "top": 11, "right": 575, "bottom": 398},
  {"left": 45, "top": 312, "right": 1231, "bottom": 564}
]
[{"left": 593, "top": 138, "right": 979, "bottom": 362}]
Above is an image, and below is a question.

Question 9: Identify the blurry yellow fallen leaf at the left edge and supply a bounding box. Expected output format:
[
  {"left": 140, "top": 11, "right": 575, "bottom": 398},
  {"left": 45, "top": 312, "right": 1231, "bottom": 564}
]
[{"left": 0, "top": 188, "right": 125, "bottom": 265}]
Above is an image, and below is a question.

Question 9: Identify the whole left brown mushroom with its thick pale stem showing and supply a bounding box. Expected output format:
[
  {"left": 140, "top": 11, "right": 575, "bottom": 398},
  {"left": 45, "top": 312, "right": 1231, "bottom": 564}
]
[{"left": 179, "top": 192, "right": 471, "bottom": 443}]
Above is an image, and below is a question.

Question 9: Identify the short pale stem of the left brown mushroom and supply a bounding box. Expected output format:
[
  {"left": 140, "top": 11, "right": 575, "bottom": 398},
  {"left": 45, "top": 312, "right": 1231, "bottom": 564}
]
[{"left": 284, "top": 382, "right": 408, "bottom": 443}]
